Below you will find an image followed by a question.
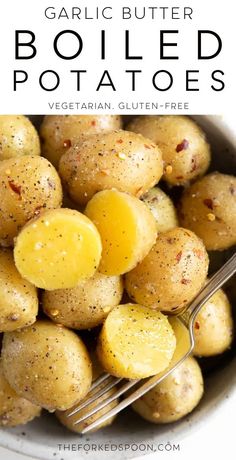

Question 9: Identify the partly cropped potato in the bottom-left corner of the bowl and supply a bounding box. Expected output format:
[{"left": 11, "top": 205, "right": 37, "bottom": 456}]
[{"left": 0, "top": 360, "right": 41, "bottom": 427}]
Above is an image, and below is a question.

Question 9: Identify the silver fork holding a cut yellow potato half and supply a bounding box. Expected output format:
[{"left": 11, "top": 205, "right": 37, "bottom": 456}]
[{"left": 67, "top": 253, "right": 236, "bottom": 434}]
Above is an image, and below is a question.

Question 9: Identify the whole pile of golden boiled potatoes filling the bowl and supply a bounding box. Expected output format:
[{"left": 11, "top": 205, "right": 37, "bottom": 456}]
[{"left": 0, "top": 115, "right": 236, "bottom": 432}]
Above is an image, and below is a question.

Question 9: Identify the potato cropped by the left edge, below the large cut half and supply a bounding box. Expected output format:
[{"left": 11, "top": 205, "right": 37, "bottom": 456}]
[{"left": 0, "top": 249, "right": 38, "bottom": 332}]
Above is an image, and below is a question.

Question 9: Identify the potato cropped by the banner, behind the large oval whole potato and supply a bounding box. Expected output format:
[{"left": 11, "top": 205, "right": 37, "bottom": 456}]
[{"left": 40, "top": 115, "right": 121, "bottom": 167}]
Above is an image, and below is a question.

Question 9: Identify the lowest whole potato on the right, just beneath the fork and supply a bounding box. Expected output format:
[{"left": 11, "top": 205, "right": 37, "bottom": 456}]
[{"left": 132, "top": 357, "right": 203, "bottom": 424}]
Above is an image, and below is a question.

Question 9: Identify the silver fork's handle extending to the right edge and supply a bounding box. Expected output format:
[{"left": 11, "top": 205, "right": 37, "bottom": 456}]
[{"left": 183, "top": 253, "right": 236, "bottom": 328}]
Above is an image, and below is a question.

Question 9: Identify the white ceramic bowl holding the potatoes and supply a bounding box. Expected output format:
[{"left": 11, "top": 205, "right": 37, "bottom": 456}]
[{"left": 0, "top": 116, "right": 236, "bottom": 460}]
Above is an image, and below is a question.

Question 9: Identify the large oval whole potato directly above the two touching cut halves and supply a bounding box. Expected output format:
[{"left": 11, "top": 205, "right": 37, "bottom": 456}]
[{"left": 59, "top": 131, "right": 163, "bottom": 205}]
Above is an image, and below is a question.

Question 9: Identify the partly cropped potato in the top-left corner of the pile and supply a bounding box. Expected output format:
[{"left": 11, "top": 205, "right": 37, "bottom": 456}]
[{"left": 0, "top": 115, "right": 40, "bottom": 160}]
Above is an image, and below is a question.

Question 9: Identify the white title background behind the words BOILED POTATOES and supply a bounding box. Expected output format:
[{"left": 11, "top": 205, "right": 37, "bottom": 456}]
[{"left": 0, "top": 0, "right": 235, "bottom": 114}]
